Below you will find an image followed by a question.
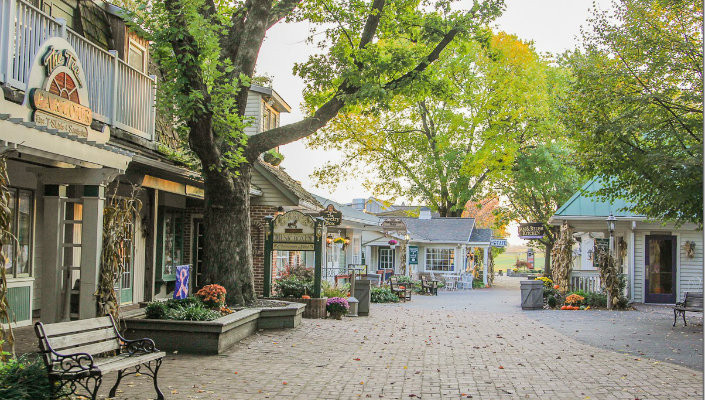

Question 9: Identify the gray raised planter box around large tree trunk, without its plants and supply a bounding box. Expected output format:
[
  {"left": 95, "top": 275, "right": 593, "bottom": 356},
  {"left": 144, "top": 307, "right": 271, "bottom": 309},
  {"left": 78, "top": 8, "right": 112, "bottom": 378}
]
[{"left": 124, "top": 303, "right": 306, "bottom": 354}]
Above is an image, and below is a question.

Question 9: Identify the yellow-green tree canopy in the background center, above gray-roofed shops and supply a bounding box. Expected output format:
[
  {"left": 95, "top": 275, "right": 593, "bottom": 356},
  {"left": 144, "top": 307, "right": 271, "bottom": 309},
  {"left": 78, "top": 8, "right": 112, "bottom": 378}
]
[{"left": 307, "top": 31, "right": 550, "bottom": 216}]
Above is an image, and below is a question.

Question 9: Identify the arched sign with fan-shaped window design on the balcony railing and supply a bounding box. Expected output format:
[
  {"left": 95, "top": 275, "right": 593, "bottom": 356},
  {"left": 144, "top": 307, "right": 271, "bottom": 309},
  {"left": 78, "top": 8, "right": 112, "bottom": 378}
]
[{"left": 25, "top": 37, "right": 110, "bottom": 143}]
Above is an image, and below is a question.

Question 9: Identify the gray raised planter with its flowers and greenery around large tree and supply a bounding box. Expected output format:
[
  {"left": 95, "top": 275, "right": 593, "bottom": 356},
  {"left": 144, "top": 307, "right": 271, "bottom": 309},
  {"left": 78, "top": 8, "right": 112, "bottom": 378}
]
[{"left": 124, "top": 285, "right": 306, "bottom": 354}]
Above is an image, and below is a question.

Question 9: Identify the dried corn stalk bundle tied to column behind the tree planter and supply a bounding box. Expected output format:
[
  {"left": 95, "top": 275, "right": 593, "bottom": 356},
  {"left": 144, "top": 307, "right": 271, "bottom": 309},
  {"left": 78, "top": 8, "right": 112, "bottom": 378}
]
[{"left": 95, "top": 187, "right": 142, "bottom": 320}]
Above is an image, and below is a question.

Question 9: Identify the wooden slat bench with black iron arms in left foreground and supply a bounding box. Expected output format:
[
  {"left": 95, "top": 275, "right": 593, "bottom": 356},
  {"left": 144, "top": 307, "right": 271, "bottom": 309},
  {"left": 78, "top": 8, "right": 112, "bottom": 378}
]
[{"left": 34, "top": 316, "right": 165, "bottom": 400}]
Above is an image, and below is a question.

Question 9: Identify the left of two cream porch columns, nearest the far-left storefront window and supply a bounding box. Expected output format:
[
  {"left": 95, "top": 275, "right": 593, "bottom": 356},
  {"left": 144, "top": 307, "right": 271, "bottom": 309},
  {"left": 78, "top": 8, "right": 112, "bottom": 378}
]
[{"left": 41, "top": 185, "right": 66, "bottom": 323}]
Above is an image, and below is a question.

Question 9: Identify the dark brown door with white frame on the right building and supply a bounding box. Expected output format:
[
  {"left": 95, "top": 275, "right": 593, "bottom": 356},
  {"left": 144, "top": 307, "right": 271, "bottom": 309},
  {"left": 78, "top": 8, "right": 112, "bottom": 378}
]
[{"left": 644, "top": 235, "right": 676, "bottom": 304}]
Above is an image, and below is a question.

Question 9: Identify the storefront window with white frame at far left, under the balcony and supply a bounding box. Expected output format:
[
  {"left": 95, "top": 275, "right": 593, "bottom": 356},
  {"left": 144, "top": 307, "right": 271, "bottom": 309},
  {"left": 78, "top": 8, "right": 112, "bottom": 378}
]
[{"left": 2, "top": 188, "right": 34, "bottom": 277}]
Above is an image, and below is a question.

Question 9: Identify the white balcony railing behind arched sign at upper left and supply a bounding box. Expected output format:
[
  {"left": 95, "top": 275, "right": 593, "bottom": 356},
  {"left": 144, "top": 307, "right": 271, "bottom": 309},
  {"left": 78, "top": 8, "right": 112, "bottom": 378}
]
[{"left": 0, "top": 0, "right": 156, "bottom": 141}]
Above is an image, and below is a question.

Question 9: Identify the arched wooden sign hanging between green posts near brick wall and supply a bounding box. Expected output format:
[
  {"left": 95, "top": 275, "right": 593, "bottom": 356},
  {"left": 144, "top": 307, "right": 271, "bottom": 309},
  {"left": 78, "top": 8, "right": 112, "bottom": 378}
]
[{"left": 272, "top": 210, "right": 316, "bottom": 251}]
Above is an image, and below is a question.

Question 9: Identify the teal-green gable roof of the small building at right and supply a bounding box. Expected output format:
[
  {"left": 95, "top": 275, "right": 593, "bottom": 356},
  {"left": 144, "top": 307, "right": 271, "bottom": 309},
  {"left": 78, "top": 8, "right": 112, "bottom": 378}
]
[{"left": 553, "top": 178, "right": 645, "bottom": 218}]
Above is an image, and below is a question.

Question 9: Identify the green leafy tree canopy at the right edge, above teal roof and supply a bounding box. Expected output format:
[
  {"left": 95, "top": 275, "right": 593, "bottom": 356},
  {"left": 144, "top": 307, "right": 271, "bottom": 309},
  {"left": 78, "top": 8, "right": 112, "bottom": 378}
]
[{"left": 563, "top": 0, "right": 703, "bottom": 227}]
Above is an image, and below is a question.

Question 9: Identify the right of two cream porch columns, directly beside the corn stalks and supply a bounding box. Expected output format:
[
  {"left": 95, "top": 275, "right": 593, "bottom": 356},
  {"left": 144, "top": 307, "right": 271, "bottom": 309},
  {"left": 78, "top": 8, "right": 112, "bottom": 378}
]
[{"left": 78, "top": 184, "right": 105, "bottom": 319}]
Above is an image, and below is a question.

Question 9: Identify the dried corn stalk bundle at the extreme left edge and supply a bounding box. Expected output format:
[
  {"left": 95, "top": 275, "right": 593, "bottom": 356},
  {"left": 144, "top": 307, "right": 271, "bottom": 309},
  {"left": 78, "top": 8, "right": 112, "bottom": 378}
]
[{"left": 0, "top": 154, "right": 15, "bottom": 361}]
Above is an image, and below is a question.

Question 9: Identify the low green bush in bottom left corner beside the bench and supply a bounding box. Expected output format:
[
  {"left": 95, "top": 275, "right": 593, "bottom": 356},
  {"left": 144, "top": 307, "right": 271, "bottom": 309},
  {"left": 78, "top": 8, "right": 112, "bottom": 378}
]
[{"left": 0, "top": 356, "right": 52, "bottom": 400}]
